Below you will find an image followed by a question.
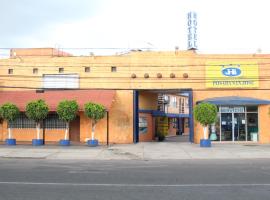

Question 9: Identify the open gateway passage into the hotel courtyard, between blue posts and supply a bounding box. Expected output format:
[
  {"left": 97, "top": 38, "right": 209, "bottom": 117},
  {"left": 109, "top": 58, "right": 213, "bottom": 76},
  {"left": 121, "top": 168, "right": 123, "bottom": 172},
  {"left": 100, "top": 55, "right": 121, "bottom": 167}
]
[{"left": 138, "top": 89, "right": 194, "bottom": 142}]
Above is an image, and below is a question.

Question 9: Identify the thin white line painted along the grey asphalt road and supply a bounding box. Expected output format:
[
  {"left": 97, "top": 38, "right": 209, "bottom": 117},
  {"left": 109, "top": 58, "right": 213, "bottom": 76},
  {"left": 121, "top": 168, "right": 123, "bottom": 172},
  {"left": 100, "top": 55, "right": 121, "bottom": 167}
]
[{"left": 0, "top": 182, "right": 270, "bottom": 187}]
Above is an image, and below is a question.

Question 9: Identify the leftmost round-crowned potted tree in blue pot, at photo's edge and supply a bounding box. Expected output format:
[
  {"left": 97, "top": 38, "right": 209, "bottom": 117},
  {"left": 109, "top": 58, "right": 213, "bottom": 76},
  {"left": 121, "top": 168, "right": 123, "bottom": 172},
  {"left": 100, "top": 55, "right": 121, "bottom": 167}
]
[{"left": 0, "top": 103, "right": 20, "bottom": 145}]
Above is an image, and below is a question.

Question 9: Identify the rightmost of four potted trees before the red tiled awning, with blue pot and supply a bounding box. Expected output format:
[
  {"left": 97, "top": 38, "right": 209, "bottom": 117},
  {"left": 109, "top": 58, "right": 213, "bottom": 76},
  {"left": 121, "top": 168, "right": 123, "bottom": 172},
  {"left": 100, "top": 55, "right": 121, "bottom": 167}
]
[{"left": 84, "top": 102, "right": 106, "bottom": 146}]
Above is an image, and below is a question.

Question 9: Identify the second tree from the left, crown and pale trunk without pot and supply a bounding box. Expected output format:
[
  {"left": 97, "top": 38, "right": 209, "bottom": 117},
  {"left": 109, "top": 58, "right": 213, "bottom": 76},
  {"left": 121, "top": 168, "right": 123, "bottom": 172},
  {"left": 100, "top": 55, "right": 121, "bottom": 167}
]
[{"left": 26, "top": 99, "right": 49, "bottom": 139}]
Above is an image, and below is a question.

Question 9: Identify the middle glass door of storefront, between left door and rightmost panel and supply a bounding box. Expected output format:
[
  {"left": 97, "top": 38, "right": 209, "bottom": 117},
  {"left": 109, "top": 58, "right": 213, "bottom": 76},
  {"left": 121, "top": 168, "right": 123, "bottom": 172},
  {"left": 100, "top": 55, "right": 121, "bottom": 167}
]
[{"left": 234, "top": 113, "right": 246, "bottom": 141}]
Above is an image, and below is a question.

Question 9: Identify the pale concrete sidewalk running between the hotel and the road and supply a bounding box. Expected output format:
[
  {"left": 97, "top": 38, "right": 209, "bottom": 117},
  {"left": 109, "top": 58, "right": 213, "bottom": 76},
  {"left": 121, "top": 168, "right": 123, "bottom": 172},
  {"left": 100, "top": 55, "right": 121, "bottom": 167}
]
[{"left": 0, "top": 142, "right": 270, "bottom": 160}]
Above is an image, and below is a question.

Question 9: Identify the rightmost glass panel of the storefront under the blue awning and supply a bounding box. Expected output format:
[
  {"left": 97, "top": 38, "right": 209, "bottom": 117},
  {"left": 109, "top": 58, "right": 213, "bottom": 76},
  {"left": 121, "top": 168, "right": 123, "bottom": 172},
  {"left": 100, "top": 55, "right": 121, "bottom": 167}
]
[{"left": 247, "top": 113, "right": 258, "bottom": 142}]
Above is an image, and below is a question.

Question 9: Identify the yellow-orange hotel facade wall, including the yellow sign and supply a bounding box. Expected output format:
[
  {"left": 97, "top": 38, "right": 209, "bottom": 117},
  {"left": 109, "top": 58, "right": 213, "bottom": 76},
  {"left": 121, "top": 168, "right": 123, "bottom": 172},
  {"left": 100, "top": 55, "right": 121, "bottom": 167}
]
[{"left": 0, "top": 50, "right": 270, "bottom": 143}]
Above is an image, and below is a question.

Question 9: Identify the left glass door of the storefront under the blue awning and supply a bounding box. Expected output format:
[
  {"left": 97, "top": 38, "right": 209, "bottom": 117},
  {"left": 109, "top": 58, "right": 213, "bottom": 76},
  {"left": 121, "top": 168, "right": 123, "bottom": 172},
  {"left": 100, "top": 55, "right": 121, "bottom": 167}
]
[{"left": 221, "top": 113, "right": 232, "bottom": 141}]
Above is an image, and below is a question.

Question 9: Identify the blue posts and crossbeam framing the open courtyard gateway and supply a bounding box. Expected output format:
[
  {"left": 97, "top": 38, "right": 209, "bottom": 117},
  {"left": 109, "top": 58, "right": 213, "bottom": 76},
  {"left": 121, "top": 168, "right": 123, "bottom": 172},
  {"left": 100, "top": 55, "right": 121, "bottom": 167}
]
[{"left": 133, "top": 90, "right": 194, "bottom": 143}]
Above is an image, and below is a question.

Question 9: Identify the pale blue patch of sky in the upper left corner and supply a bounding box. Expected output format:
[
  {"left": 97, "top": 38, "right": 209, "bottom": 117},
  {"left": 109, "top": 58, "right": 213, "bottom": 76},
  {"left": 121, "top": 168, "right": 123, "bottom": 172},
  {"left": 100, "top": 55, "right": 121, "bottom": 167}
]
[{"left": 0, "top": 0, "right": 103, "bottom": 47}]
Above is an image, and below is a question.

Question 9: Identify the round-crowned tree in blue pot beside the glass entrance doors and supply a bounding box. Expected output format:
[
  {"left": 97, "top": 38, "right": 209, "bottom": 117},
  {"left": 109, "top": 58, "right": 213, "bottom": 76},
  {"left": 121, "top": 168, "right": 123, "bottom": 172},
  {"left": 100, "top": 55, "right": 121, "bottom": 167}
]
[{"left": 194, "top": 103, "right": 217, "bottom": 147}]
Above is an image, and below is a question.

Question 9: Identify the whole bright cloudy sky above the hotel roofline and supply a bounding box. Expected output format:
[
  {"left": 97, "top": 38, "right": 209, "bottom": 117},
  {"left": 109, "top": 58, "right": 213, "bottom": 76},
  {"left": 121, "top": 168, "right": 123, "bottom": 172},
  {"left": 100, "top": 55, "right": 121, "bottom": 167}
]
[{"left": 0, "top": 0, "right": 270, "bottom": 54}]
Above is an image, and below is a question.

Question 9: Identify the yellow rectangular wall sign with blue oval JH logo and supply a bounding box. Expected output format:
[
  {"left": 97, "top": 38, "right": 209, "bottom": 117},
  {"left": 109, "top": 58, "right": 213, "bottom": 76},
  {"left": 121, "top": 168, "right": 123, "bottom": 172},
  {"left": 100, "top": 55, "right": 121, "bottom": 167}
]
[{"left": 205, "top": 61, "right": 259, "bottom": 88}]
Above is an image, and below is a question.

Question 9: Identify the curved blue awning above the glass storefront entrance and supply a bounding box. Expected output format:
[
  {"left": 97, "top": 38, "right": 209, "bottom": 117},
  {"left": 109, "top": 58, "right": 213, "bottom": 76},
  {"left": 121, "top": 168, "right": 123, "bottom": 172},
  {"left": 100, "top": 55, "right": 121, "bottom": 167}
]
[{"left": 197, "top": 96, "right": 270, "bottom": 105}]
